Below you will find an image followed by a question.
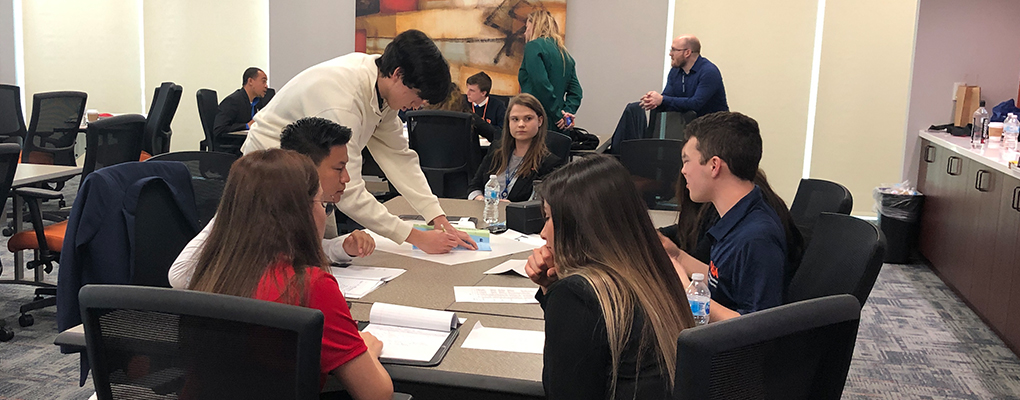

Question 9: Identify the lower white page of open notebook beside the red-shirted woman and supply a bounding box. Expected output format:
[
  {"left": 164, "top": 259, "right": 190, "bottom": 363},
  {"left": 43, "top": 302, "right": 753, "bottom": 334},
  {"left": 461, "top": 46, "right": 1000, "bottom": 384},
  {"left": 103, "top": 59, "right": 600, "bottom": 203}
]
[{"left": 363, "top": 323, "right": 450, "bottom": 361}]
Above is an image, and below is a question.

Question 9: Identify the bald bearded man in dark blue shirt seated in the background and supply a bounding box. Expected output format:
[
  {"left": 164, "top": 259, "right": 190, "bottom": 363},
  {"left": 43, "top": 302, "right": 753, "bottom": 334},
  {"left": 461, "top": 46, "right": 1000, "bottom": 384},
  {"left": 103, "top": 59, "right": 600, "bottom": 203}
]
[{"left": 613, "top": 35, "right": 729, "bottom": 147}]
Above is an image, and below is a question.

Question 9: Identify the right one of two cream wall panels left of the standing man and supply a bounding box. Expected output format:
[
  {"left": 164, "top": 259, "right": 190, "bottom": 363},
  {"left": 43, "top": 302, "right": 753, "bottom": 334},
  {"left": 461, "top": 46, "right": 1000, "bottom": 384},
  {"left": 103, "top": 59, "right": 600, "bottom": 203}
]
[{"left": 144, "top": 0, "right": 278, "bottom": 151}]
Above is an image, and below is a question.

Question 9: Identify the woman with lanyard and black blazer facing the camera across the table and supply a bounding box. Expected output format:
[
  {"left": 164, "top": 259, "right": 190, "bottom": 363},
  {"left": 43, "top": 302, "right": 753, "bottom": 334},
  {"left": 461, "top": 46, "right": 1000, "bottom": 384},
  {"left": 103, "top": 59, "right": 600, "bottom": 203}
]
[{"left": 467, "top": 93, "right": 562, "bottom": 201}]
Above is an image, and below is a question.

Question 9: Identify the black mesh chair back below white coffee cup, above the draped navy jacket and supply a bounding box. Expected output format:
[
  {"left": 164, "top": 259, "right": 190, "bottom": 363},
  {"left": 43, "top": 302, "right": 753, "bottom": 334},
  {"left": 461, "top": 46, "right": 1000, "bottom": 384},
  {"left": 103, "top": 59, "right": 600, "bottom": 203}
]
[{"left": 82, "top": 114, "right": 145, "bottom": 180}]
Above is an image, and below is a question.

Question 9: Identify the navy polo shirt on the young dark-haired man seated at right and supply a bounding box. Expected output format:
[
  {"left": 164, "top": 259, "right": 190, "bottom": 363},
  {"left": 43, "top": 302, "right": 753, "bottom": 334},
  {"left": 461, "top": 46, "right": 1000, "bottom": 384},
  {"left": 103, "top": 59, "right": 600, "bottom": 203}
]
[{"left": 707, "top": 186, "right": 786, "bottom": 314}]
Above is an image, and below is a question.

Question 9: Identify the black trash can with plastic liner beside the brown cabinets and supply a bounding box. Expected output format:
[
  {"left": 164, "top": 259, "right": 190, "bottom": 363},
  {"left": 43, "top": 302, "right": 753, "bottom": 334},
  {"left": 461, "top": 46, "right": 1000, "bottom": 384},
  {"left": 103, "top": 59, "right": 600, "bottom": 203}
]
[{"left": 875, "top": 188, "right": 924, "bottom": 264}]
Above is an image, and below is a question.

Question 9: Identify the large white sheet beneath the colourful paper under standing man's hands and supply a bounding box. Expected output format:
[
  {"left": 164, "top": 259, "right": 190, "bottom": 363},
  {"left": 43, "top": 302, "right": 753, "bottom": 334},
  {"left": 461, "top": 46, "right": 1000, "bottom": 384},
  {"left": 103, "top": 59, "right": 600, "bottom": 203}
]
[{"left": 369, "top": 231, "right": 542, "bottom": 265}]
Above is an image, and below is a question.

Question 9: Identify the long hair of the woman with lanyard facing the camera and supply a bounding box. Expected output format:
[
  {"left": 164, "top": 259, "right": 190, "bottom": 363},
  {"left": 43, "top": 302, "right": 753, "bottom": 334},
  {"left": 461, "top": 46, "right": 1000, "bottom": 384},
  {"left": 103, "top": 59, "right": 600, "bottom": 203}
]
[{"left": 489, "top": 93, "right": 549, "bottom": 178}]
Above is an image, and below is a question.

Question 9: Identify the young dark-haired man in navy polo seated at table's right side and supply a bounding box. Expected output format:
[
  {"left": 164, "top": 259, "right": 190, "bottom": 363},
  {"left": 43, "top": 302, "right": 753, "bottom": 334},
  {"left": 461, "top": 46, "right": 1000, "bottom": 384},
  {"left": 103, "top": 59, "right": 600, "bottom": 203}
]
[{"left": 678, "top": 111, "right": 786, "bottom": 321}]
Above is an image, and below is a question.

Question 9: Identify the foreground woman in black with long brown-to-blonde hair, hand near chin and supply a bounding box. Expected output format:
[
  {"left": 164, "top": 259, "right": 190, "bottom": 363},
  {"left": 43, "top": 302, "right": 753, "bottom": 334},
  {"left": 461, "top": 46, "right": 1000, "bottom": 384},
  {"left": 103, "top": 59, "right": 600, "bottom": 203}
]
[{"left": 525, "top": 155, "right": 695, "bottom": 399}]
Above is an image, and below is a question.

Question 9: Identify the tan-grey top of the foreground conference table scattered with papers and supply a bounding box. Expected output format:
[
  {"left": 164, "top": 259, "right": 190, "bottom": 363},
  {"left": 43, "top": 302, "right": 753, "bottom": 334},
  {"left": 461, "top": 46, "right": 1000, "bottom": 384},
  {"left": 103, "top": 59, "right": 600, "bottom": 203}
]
[{"left": 55, "top": 197, "right": 676, "bottom": 399}]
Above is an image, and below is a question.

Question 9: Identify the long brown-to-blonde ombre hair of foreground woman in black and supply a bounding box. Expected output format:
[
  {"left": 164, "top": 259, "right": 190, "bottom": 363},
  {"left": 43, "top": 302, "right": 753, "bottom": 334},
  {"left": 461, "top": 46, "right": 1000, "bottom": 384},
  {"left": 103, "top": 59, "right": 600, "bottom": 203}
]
[{"left": 539, "top": 155, "right": 695, "bottom": 398}]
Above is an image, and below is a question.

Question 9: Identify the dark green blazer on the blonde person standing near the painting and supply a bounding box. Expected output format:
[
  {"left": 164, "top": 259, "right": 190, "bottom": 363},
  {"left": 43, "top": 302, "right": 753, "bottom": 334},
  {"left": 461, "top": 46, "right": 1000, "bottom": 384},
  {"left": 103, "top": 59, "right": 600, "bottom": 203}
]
[{"left": 518, "top": 38, "right": 581, "bottom": 126}]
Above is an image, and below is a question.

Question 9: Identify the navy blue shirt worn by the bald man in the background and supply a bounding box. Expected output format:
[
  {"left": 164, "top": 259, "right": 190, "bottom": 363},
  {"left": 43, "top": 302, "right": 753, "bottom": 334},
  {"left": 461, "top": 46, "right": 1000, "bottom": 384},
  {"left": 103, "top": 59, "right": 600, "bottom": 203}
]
[{"left": 659, "top": 56, "right": 729, "bottom": 116}]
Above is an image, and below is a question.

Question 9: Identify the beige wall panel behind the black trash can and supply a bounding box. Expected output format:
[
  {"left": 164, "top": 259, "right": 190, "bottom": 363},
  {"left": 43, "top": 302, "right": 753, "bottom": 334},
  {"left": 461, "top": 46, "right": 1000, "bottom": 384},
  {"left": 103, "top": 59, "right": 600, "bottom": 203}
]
[{"left": 811, "top": 0, "right": 922, "bottom": 215}]
